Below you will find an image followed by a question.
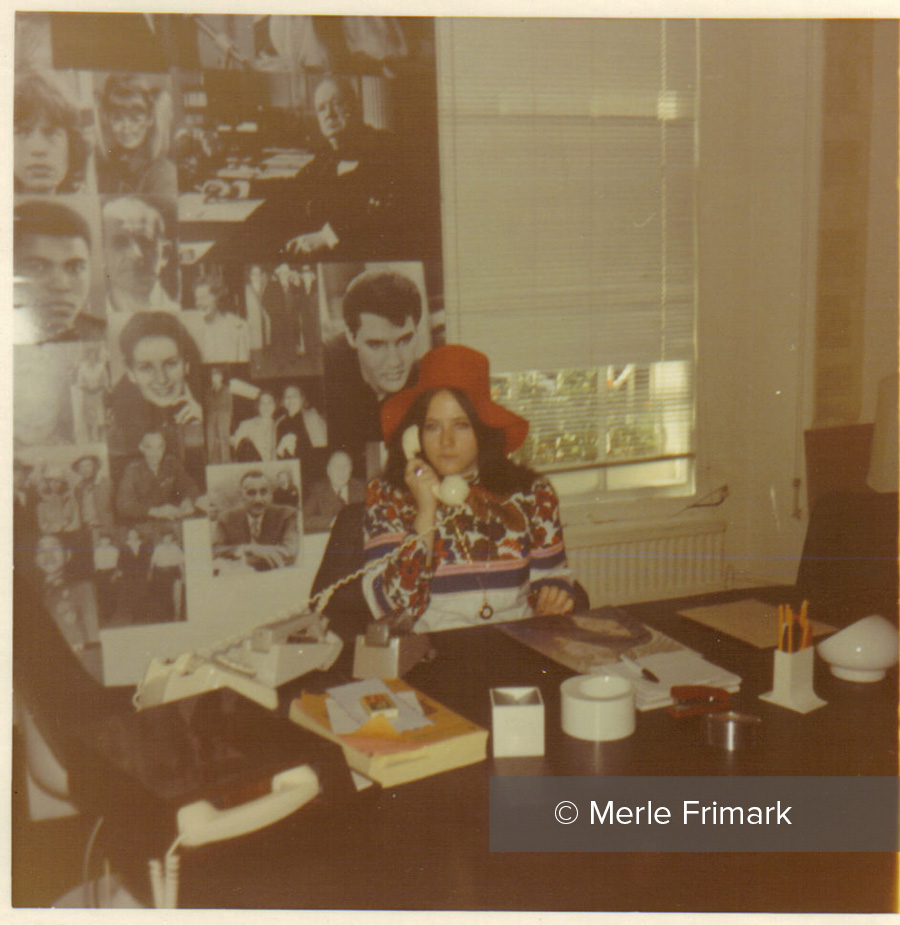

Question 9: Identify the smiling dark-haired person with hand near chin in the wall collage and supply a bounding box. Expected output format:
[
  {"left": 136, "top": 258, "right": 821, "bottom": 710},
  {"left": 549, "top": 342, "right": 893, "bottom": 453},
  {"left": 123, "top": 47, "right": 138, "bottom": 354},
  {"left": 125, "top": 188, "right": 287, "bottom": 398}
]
[{"left": 109, "top": 312, "right": 203, "bottom": 470}]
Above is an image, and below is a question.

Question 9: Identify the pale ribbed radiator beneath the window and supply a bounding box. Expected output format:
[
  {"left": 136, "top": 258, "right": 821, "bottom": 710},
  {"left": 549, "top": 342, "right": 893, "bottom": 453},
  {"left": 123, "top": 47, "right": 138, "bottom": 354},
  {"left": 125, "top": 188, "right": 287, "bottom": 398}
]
[{"left": 565, "top": 521, "right": 727, "bottom": 607}]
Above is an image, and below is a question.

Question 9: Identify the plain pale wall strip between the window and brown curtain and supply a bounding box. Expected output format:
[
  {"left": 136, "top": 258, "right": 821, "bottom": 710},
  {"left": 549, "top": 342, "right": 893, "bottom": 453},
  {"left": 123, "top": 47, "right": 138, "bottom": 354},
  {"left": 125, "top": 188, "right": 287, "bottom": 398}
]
[{"left": 698, "top": 21, "right": 821, "bottom": 585}]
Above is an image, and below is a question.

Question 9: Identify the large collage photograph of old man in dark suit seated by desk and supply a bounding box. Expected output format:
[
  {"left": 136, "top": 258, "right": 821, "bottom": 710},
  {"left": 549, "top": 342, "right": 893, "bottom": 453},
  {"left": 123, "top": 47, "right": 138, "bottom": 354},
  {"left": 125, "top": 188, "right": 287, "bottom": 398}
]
[{"left": 175, "top": 60, "right": 440, "bottom": 262}]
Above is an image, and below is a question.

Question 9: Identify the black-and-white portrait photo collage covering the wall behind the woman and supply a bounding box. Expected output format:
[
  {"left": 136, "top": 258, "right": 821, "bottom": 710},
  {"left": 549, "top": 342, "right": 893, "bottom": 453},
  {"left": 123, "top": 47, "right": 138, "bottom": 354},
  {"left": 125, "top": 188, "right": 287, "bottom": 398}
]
[{"left": 12, "top": 12, "right": 443, "bottom": 651}]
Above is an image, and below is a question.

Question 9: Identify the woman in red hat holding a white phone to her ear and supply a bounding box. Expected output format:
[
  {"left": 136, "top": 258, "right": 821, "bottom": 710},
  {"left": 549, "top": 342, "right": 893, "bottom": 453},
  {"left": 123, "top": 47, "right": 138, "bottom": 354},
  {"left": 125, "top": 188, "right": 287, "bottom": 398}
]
[{"left": 363, "top": 345, "right": 574, "bottom": 631}]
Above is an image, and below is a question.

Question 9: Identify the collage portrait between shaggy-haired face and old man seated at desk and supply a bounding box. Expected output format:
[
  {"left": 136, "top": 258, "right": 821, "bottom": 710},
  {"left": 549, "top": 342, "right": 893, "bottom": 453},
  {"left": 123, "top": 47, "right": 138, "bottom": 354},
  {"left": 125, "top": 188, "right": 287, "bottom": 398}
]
[{"left": 97, "top": 74, "right": 178, "bottom": 196}]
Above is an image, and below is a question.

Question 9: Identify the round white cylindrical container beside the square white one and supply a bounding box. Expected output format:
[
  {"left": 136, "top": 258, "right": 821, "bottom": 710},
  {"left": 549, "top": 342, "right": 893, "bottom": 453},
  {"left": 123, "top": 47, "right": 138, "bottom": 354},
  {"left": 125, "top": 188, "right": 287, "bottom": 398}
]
[{"left": 560, "top": 674, "right": 634, "bottom": 742}]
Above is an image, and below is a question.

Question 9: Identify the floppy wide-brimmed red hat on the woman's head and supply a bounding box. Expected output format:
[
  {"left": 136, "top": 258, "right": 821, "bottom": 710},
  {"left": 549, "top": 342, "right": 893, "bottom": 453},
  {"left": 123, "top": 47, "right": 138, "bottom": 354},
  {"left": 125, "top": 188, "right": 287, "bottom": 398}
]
[{"left": 381, "top": 344, "right": 528, "bottom": 453}]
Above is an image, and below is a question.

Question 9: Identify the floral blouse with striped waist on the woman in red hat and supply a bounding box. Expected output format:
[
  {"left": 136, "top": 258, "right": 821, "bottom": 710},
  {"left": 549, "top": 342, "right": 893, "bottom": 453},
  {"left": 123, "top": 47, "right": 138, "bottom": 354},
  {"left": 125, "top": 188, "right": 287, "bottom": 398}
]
[{"left": 363, "top": 477, "right": 572, "bottom": 632}]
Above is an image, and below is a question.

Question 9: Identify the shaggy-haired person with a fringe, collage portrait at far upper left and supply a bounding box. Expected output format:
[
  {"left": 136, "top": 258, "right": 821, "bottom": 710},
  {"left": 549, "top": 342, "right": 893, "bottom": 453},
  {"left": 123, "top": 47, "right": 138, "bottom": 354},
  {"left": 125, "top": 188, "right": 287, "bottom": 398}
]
[{"left": 13, "top": 72, "right": 90, "bottom": 194}]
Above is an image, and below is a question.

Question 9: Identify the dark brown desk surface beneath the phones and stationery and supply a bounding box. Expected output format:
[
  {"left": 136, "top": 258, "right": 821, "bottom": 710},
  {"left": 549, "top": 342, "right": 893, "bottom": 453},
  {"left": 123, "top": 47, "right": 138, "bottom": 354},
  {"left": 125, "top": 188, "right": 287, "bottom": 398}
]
[{"left": 51, "top": 592, "right": 897, "bottom": 912}]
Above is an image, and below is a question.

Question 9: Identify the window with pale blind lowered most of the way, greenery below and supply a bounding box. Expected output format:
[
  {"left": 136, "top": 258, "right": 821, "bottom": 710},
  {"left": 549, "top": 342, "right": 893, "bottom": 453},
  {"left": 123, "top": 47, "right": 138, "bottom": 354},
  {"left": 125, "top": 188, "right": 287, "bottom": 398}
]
[{"left": 439, "top": 19, "right": 697, "bottom": 490}]
